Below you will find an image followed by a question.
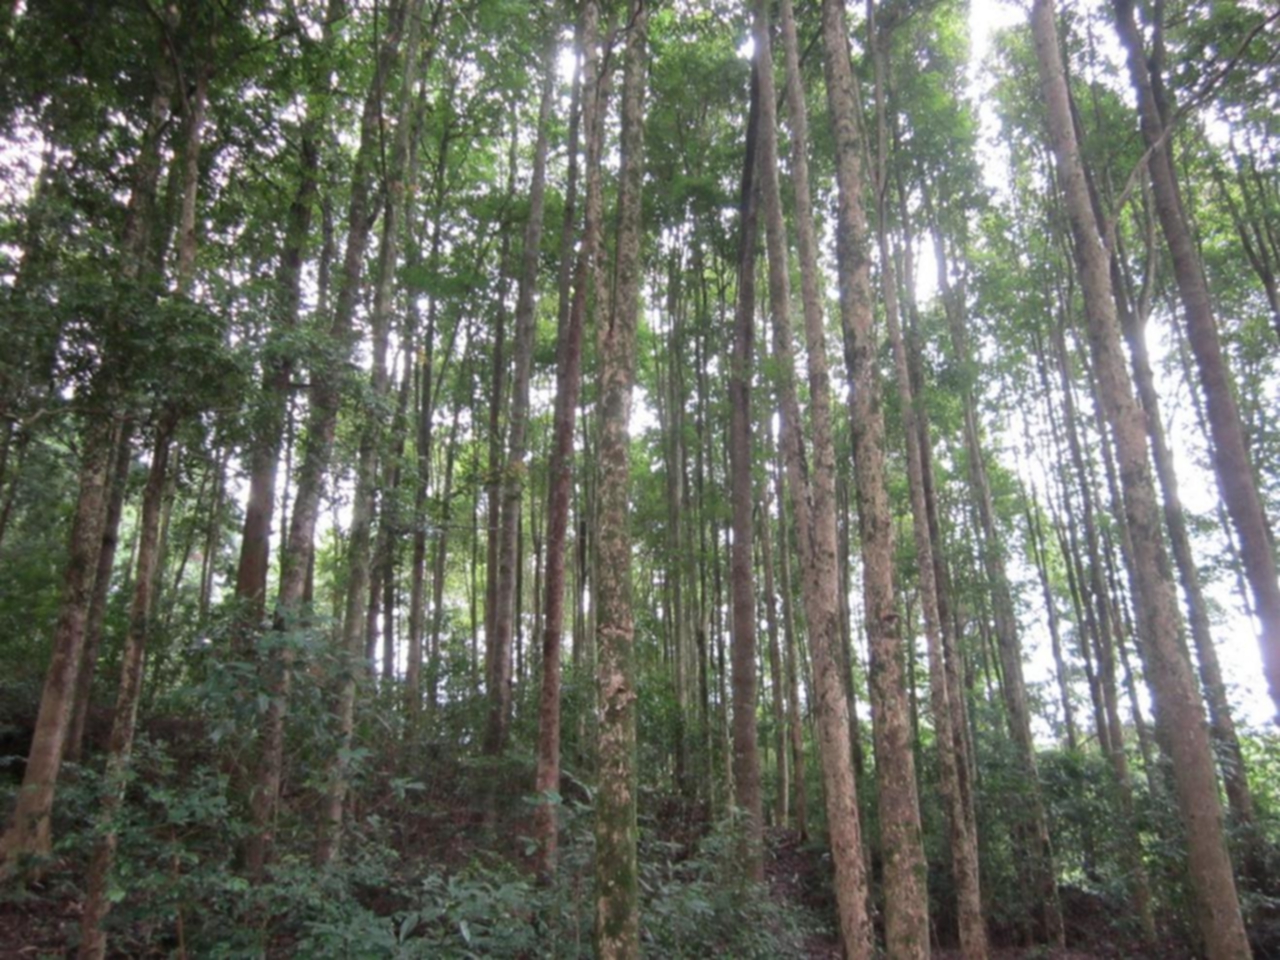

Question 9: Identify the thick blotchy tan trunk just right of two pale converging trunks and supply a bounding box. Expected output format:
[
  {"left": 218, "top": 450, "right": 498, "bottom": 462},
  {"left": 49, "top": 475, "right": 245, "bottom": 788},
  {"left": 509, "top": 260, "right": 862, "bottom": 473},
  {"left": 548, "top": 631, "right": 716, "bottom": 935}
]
[{"left": 824, "top": 0, "right": 929, "bottom": 957}]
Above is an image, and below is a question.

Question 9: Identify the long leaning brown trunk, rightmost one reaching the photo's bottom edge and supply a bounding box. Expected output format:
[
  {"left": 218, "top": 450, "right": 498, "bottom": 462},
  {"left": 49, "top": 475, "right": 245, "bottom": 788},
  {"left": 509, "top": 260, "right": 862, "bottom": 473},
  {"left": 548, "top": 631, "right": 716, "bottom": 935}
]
[{"left": 1032, "top": 0, "right": 1252, "bottom": 960}]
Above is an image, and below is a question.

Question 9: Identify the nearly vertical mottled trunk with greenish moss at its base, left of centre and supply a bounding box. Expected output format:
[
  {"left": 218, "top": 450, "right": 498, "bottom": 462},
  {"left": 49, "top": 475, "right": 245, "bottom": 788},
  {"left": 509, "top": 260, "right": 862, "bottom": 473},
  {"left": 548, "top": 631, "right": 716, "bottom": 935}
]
[{"left": 594, "top": 0, "right": 649, "bottom": 960}]
